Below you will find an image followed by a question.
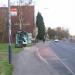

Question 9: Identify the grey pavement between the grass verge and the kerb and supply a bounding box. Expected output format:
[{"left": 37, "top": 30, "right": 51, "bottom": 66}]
[{"left": 13, "top": 42, "right": 59, "bottom": 75}]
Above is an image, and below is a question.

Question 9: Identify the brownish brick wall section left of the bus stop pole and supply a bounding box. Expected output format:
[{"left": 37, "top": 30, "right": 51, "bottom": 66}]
[{"left": 0, "top": 7, "right": 8, "bottom": 42}]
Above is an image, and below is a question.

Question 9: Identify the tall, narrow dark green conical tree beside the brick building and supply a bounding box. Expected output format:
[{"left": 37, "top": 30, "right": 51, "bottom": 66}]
[{"left": 36, "top": 12, "right": 45, "bottom": 40}]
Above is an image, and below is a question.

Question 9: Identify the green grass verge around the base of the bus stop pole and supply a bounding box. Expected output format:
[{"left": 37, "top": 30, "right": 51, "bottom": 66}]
[{"left": 0, "top": 43, "right": 22, "bottom": 75}]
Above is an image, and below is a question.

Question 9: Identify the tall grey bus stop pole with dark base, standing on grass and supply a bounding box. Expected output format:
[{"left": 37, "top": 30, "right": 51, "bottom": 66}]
[{"left": 8, "top": 0, "right": 12, "bottom": 64}]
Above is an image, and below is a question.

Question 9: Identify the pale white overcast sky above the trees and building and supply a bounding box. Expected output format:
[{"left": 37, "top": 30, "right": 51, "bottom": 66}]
[{"left": 0, "top": 0, "right": 75, "bottom": 35}]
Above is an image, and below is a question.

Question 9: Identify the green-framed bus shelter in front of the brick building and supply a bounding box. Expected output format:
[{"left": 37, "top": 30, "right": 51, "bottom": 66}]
[{"left": 16, "top": 31, "right": 28, "bottom": 47}]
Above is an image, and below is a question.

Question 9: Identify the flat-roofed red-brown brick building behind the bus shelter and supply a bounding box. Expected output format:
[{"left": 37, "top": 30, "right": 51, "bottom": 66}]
[{"left": 0, "top": 6, "right": 36, "bottom": 41}]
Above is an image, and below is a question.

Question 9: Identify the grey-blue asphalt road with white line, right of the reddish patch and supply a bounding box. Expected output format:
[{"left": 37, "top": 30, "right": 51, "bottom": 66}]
[{"left": 47, "top": 41, "right": 75, "bottom": 75}]
